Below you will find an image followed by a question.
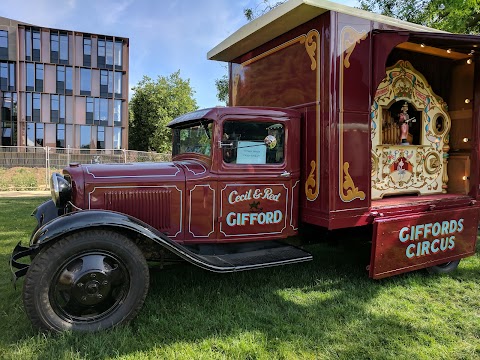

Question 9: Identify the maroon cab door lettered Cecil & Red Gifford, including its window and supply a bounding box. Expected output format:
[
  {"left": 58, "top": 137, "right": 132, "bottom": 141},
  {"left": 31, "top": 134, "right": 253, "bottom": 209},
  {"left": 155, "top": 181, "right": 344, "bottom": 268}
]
[{"left": 217, "top": 117, "right": 300, "bottom": 242}]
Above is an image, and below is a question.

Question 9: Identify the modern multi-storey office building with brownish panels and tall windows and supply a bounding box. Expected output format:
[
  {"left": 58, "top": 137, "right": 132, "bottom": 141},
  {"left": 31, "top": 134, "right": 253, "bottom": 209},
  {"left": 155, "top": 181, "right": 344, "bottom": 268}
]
[{"left": 0, "top": 17, "right": 129, "bottom": 149}]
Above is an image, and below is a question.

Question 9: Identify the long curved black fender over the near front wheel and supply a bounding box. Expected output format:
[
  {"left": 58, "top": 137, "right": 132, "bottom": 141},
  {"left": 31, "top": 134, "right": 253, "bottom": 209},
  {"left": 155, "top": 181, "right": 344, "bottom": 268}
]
[{"left": 30, "top": 210, "right": 236, "bottom": 273}]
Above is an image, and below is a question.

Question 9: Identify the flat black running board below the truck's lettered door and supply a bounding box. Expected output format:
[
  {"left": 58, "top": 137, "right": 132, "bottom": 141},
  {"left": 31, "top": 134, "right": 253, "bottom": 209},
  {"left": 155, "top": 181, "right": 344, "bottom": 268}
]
[{"left": 185, "top": 241, "right": 313, "bottom": 272}]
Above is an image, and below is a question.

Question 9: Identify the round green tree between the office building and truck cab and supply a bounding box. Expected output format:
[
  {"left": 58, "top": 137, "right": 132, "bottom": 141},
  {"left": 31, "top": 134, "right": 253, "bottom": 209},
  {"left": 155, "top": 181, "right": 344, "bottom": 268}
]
[{"left": 128, "top": 70, "right": 197, "bottom": 152}]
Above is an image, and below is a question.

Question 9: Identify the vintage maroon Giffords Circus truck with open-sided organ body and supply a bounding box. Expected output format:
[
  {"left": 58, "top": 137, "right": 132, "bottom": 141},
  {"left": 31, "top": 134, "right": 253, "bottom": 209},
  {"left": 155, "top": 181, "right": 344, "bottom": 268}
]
[{"left": 11, "top": 0, "right": 480, "bottom": 331}]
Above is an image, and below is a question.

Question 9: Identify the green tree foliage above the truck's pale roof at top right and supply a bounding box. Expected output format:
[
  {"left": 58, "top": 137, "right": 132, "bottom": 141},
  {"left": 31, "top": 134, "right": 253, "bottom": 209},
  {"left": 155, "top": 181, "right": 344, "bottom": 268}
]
[{"left": 359, "top": 0, "right": 480, "bottom": 34}]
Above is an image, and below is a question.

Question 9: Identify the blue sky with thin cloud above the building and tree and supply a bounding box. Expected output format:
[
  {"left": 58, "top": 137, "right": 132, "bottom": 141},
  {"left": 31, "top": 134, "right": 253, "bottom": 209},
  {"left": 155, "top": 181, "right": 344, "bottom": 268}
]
[{"left": 0, "top": 0, "right": 357, "bottom": 108}]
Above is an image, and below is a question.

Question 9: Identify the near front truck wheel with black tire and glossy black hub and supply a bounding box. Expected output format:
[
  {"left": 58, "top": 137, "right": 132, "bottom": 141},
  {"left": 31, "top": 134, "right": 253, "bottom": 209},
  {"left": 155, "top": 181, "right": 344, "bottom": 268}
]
[{"left": 23, "top": 230, "right": 149, "bottom": 332}]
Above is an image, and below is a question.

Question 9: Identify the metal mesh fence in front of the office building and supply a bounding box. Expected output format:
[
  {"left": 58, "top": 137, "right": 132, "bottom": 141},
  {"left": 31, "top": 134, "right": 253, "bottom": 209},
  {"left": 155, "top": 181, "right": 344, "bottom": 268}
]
[{"left": 0, "top": 146, "right": 171, "bottom": 190}]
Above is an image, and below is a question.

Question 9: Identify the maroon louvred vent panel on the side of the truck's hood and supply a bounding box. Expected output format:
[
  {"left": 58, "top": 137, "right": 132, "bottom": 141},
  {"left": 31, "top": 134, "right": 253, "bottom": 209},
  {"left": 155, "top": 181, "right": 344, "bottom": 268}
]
[{"left": 105, "top": 189, "right": 171, "bottom": 233}]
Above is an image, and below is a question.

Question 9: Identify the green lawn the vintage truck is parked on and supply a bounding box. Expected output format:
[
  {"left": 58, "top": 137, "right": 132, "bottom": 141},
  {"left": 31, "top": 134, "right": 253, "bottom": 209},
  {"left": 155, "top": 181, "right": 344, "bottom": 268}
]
[{"left": 0, "top": 198, "right": 480, "bottom": 360}]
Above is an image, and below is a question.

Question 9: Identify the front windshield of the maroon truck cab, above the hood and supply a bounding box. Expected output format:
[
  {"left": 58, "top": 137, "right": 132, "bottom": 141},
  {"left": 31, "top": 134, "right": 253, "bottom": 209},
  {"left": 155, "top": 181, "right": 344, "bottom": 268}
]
[{"left": 173, "top": 121, "right": 213, "bottom": 156}]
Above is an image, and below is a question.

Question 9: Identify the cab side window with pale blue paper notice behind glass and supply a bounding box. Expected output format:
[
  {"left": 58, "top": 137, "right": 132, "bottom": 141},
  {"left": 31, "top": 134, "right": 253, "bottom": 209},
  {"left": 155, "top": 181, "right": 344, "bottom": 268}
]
[{"left": 222, "top": 121, "right": 285, "bottom": 165}]
